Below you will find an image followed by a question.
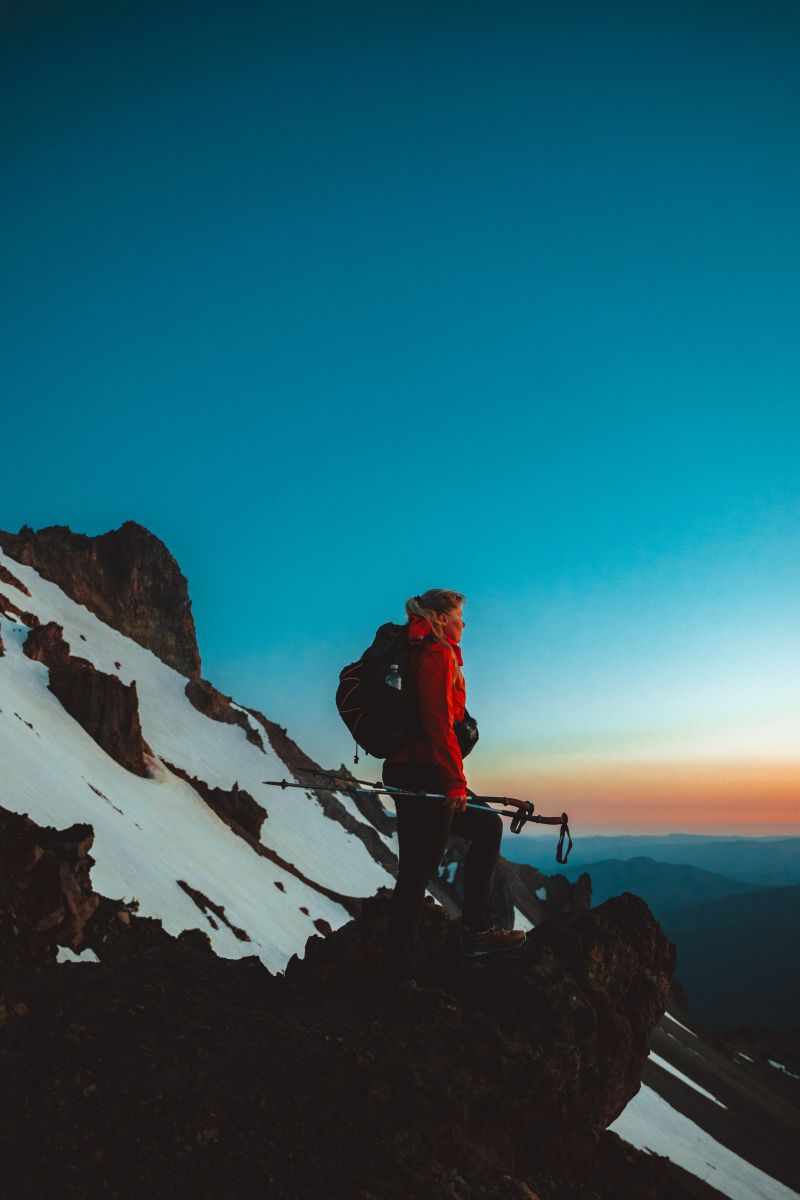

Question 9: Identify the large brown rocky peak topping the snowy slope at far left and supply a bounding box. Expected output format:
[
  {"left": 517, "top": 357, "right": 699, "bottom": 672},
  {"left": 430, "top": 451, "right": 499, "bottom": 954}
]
[{"left": 0, "top": 521, "right": 200, "bottom": 677}]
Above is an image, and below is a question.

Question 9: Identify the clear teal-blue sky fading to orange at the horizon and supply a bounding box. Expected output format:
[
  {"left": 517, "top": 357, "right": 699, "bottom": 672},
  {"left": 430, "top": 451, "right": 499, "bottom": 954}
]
[{"left": 0, "top": 0, "right": 800, "bottom": 834}]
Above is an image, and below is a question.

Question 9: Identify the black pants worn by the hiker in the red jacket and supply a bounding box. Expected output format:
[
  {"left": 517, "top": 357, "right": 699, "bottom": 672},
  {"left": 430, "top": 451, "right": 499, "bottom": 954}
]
[{"left": 384, "top": 762, "right": 503, "bottom": 979}]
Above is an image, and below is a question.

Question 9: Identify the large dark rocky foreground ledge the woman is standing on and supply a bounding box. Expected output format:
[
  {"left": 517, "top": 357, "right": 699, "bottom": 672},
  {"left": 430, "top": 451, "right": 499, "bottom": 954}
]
[{"left": 0, "top": 825, "right": 681, "bottom": 1200}]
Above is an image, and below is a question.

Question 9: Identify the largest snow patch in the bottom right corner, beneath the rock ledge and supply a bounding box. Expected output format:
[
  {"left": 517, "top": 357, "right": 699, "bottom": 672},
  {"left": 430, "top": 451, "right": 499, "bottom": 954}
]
[{"left": 610, "top": 1085, "right": 799, "bottom": 1200}]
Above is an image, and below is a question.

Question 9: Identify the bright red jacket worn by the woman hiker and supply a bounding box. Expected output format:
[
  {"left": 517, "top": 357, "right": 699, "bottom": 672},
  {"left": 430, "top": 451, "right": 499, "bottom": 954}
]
[{"left": 391, "top": 617, "right": 467, "bottom": 796}]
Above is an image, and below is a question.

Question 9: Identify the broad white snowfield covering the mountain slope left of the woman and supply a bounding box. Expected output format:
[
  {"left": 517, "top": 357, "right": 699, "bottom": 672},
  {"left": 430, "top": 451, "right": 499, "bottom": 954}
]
[{"left": 0, "top": 552, "right": 393, "bottom": 971}]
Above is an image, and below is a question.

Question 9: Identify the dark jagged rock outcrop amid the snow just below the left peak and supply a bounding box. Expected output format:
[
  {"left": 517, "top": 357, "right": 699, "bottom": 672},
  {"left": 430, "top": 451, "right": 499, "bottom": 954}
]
[{"left": 23, "top": 622, "right": 150, "bottom": 778}]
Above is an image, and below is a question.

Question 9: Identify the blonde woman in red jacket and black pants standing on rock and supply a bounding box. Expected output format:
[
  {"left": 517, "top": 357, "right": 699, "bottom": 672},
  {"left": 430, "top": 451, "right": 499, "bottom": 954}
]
[{"left": 384, "top": 588, "right": 525, "bottom": 982}]
